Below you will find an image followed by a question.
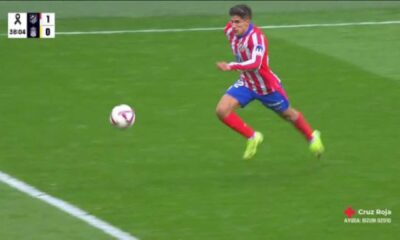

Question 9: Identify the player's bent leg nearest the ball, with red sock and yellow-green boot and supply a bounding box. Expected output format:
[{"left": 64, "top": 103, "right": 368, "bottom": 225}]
[{"left": 216, "top": 81, "right": 263, "bottom": 159}]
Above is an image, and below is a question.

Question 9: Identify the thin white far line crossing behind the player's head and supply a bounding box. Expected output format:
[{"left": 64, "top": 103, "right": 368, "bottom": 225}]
[{"left": 56, "top": 20, "right": 400, "bottom": 35}]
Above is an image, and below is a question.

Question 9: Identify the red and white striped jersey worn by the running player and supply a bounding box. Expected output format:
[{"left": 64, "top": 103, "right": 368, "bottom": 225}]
[{"left": 224, "top": 22, "right": 284, "bottom": 95}]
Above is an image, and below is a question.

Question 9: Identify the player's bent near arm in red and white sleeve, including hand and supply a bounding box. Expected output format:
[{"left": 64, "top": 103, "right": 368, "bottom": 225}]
[{"left": 229, "top": 33, "right": 266, "bottom": 71}]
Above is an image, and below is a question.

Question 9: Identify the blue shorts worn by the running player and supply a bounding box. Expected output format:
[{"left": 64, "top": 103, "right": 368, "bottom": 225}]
[{"left": 226, "top": 80, "right": 289, "bottom": 113}]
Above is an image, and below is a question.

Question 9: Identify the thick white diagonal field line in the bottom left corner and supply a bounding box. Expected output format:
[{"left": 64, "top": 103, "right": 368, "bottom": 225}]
[{"left": 0, "top": 171, "right": 138, "bottom": 240}]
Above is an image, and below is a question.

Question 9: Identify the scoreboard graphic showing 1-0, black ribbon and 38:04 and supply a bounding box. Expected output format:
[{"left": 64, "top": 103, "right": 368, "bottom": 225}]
[{"left": 8, "top": 12, "right": 56, "bottom": 38}]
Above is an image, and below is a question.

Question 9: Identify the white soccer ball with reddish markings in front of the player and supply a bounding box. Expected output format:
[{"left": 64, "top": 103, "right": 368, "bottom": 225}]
[{"left": 110, "top": 104, "right": 136, "bottom": 128}]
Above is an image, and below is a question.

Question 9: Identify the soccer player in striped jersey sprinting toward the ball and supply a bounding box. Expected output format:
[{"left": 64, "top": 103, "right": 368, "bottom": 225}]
[{"left": 216, "top": 5, "right": 324, "bottom": 159}]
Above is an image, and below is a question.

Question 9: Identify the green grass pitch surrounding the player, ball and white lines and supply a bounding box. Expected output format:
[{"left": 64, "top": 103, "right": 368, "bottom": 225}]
[{"left": 0, "top": 1, "right": 400, "bottom": 240}]
